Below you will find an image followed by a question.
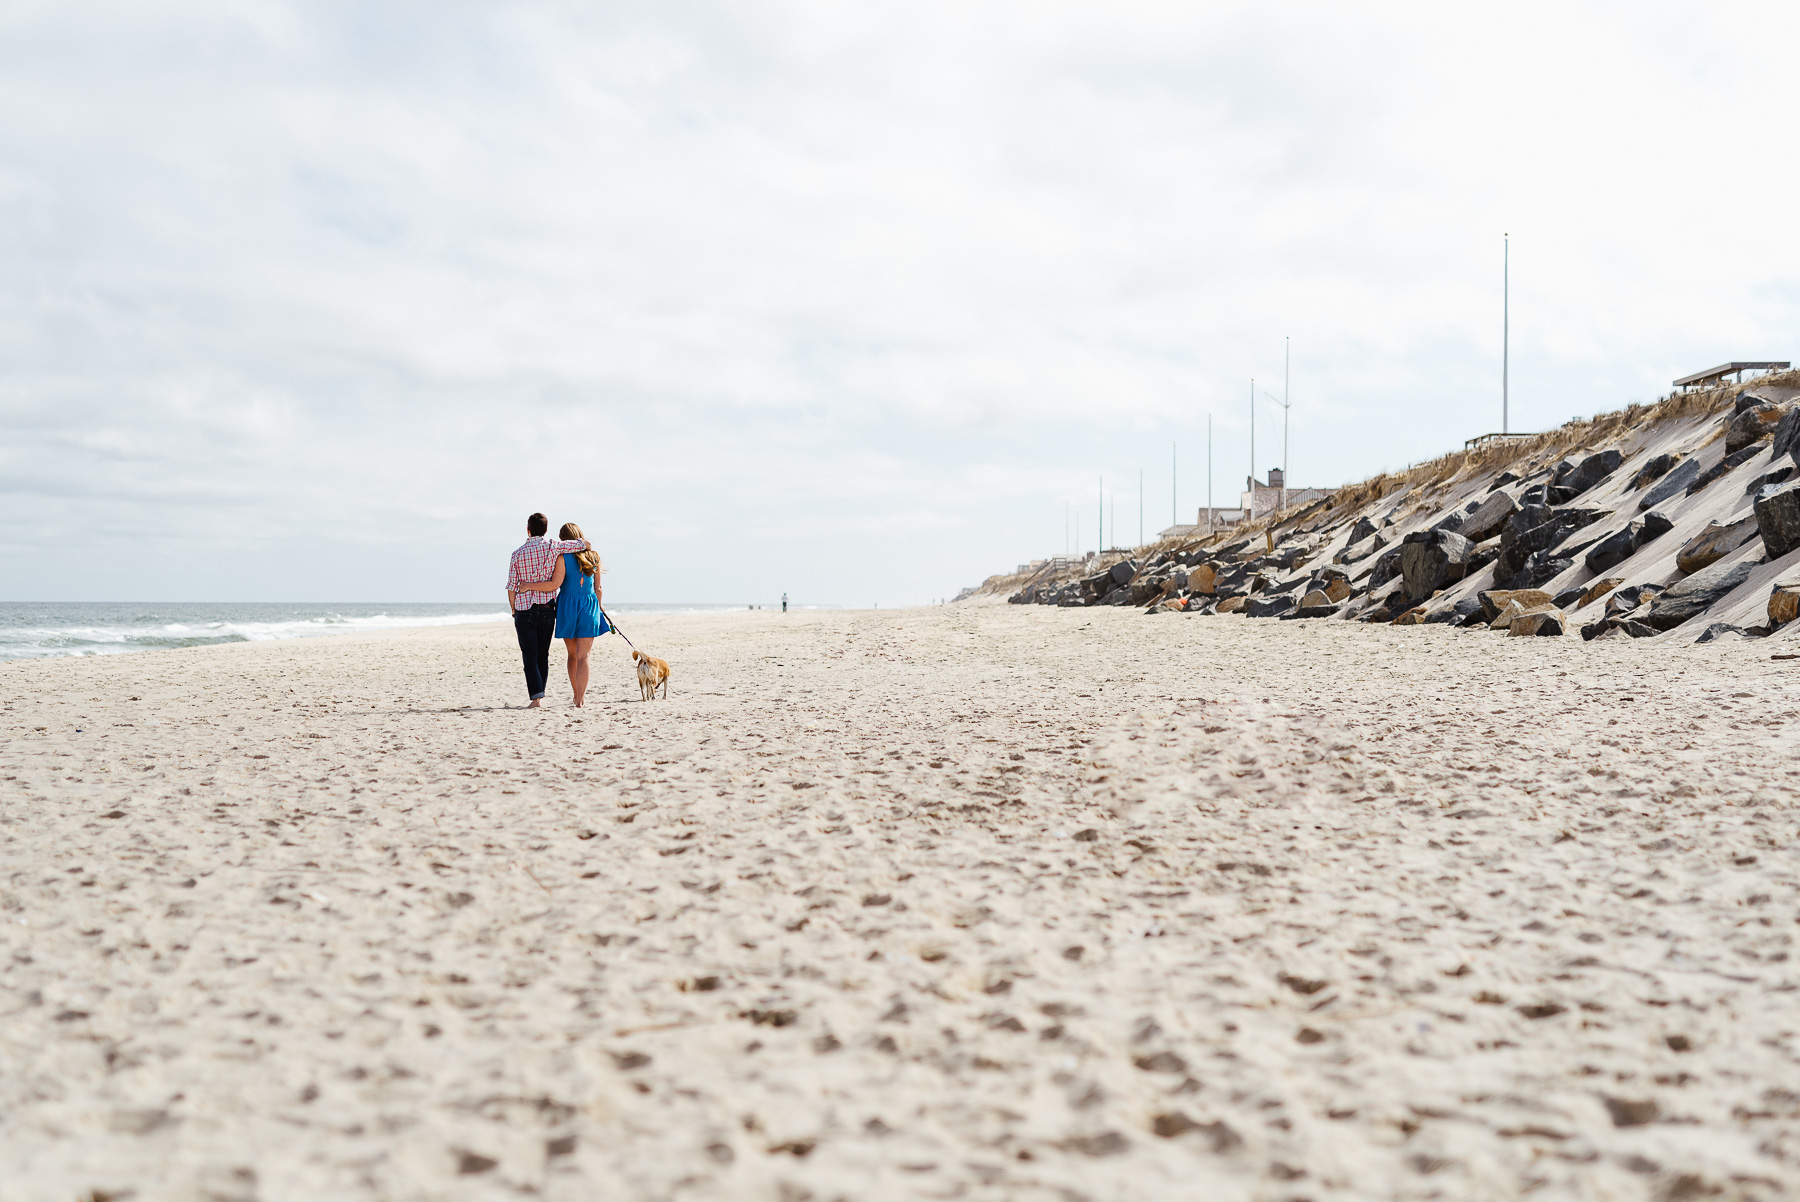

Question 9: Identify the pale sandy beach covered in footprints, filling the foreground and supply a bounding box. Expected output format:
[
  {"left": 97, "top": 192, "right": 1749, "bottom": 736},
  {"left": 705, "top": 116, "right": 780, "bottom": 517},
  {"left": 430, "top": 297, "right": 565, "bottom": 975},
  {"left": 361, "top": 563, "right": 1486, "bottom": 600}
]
[{"left": 0, "top": 605, "right": 1800, "bottom": 1202}]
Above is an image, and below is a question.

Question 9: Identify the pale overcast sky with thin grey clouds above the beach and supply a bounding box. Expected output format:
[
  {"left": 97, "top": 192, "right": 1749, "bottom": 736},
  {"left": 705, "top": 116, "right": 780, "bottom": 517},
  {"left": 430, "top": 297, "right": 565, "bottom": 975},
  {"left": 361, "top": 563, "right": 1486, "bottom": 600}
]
[{"left": 0, "top": 0, "right": 1800, "bottom": 605}]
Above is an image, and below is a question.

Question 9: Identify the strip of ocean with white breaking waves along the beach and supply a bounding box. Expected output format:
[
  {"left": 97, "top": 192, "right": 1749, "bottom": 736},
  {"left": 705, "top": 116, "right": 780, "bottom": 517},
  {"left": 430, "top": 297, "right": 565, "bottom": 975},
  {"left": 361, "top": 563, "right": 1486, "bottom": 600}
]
[{"left": 0, "top": 601, "right": 745, "bottom": 660}]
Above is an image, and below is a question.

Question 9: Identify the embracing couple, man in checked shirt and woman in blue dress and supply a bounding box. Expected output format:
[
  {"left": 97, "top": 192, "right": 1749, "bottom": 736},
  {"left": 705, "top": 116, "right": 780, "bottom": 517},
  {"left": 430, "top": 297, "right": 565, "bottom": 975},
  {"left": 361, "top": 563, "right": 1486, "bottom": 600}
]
[{"left": 506, "top": 513, "right": 612, "bottom": 709}]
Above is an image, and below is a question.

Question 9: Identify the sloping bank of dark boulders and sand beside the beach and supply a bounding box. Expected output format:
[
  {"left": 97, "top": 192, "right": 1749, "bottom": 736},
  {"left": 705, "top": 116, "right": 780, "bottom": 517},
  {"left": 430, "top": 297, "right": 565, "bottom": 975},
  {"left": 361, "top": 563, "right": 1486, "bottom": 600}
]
[{"left": 990, "top": 372, "right": 1800, "bottom": 641}]
